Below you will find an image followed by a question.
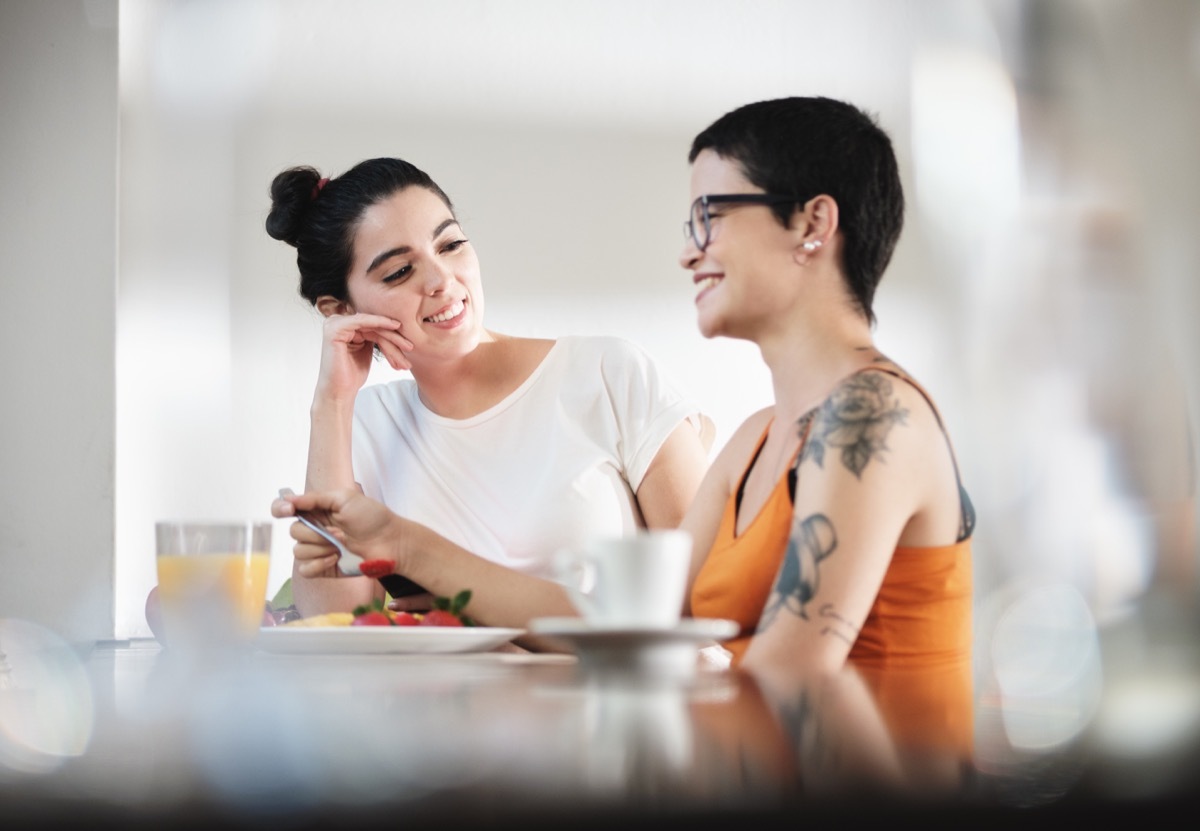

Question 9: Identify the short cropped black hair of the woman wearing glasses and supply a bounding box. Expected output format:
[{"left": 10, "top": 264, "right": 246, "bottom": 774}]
[{"left": 688, "top": 97, "right": 905, "bottom": 324}]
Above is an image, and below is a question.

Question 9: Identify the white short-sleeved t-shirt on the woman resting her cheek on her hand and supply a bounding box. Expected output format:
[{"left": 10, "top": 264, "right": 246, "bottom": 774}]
[{"left": 353, "top": 336, "right": 710, "bottom": 578}]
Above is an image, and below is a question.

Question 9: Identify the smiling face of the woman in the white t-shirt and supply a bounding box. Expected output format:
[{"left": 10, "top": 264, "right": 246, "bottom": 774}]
[{"left": 347, "top": 186, "right": 486, "bottom": 366}]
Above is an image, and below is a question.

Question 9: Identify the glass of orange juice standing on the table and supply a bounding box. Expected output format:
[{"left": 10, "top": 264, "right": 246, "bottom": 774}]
[{"left": 155, "top": 521, "right": 271, "bottom": 651}]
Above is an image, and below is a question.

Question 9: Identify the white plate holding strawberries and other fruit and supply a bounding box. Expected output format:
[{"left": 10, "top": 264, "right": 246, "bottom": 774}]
[{"left": 257, "top": 626, "right": 524, "bottom": 654}]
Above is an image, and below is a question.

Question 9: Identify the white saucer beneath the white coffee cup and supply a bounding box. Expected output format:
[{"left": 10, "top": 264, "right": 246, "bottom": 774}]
[{"left": 529, "top": 617, "right": 738, "bottom": 675}]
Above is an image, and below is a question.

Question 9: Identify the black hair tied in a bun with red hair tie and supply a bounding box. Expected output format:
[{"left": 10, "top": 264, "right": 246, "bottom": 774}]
[{"left": 266, "top": 157, "right": 454, "bottom": 305}]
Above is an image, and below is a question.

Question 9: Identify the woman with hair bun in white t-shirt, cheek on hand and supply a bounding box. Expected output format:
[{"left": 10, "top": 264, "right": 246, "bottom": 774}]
[{"left": 266, "top": 159, "right": 712, "bottom": 627}]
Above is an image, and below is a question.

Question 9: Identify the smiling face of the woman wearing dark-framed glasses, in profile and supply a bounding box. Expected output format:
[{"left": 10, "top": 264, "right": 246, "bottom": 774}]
[{"left": 679, "top": 150, "right": 796, "bottom": 340}]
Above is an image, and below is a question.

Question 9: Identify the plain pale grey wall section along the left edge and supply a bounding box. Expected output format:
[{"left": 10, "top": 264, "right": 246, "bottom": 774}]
[{"left": 0, "top": 0, "right": 118, "bottom": 652}]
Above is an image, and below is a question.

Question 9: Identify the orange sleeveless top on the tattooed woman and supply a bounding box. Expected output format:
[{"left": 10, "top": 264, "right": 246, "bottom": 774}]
[{"left": 691, "top": 367, "right": 973, "bottom": 747}]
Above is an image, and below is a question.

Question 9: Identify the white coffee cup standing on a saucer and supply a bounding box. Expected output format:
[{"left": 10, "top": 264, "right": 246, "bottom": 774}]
[{"left": 554, "top": 530, "right": 691, "bottom": 629}]
